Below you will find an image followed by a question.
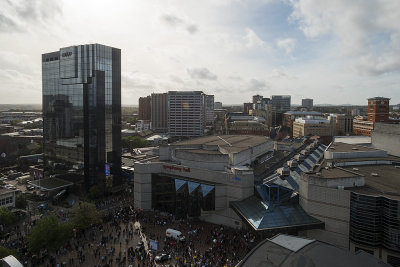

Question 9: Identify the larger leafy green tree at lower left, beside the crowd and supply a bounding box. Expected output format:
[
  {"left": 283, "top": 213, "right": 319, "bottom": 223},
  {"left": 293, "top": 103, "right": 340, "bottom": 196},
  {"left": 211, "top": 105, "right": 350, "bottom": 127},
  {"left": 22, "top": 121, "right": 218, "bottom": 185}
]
[{"left": 27, "top": 215, "right": 73, "bottom": 253}]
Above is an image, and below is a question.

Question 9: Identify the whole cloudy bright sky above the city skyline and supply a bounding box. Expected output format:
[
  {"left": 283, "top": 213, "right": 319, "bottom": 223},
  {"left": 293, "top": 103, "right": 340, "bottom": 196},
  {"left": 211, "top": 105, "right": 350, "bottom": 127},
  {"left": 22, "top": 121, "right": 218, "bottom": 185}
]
[{"left": 0, "top": 0, "right": 400, "bottom": 105}]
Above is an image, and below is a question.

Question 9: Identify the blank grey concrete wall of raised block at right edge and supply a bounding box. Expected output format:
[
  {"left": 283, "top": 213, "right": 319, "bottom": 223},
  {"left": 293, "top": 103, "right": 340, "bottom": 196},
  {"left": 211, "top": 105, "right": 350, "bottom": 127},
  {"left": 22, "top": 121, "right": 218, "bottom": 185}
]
[{"left": 371, "top": 123, "right": 400, "bottom": 157}]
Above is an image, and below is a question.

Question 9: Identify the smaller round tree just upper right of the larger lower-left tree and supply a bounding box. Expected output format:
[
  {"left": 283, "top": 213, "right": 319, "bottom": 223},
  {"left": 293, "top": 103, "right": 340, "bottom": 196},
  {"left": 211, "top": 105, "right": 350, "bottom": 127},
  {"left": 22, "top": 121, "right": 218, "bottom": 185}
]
[{"left": 72, "top": 202, "right": 100, "bottom": 229}]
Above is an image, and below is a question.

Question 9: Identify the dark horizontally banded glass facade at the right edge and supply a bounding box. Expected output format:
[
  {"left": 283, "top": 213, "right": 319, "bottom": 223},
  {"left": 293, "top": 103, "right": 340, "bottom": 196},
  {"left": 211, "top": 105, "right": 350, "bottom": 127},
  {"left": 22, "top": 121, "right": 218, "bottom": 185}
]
[{"left": 350, "top": 192, "right": 400, "bottom": 252}]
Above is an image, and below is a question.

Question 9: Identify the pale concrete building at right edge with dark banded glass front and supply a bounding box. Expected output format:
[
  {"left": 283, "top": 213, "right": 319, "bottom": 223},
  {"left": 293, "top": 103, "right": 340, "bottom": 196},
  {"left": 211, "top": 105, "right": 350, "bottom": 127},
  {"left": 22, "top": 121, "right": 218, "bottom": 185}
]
[{"left": 299, "top": 140, "right": 400, "bottom": 266}]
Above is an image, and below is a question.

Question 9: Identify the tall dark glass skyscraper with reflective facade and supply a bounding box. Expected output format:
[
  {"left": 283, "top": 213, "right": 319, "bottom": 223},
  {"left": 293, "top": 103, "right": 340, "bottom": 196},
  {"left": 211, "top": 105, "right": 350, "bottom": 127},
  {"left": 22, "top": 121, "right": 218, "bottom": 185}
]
[{"left": 42, "top": 44, "right": 121, "bottom": 189}]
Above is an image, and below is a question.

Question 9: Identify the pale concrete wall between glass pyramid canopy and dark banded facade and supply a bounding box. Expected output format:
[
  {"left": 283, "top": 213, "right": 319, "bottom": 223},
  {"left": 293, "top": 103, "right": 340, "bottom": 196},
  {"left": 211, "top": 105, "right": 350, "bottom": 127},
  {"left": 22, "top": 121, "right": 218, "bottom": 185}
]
[{"left": 299, "top": 176, "right": 350, "bottom": 249}]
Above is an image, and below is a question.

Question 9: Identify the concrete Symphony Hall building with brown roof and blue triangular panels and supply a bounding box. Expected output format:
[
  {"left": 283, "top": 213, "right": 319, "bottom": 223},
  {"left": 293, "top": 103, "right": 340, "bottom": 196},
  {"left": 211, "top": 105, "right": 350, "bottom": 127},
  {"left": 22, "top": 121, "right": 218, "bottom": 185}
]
[{"left": 134, "top": 135, "right": 274, "bottom": 227}]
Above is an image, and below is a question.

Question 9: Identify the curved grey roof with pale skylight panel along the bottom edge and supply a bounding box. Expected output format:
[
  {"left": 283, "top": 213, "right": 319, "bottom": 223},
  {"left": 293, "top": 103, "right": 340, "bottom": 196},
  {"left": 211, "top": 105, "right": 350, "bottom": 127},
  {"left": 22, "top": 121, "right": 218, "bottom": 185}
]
[{"left": 237, "top": 234, "right": 390, "bottom": 267}]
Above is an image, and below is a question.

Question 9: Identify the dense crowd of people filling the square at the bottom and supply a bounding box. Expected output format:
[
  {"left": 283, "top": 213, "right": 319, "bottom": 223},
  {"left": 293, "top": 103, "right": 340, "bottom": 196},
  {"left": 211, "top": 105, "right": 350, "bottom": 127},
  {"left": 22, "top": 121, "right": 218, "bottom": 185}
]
[{"left": 0, "top": 195, "right": 260, "bottom": 267}]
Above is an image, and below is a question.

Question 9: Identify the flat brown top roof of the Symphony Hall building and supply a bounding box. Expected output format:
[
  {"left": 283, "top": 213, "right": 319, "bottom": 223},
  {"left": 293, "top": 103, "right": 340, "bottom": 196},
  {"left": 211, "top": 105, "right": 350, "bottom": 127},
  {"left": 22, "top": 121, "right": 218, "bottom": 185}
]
[{"left": 171, "top": 135, "right": 272, "bottom": 153}]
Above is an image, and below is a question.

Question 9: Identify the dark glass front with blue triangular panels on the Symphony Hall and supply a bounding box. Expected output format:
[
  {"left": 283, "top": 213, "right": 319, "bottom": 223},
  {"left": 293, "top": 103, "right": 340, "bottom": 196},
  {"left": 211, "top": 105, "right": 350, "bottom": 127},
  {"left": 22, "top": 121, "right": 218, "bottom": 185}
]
[{"left": 151, "top": 174, "right": 215, "bottom": 219}]
